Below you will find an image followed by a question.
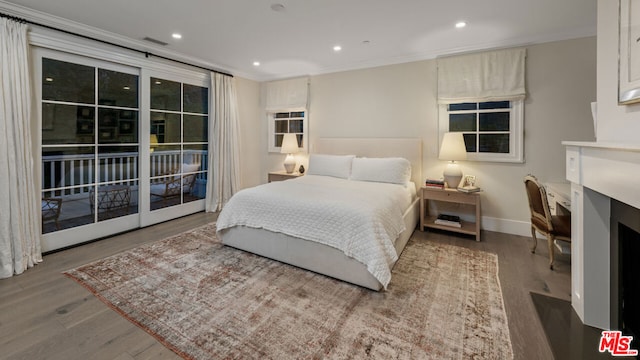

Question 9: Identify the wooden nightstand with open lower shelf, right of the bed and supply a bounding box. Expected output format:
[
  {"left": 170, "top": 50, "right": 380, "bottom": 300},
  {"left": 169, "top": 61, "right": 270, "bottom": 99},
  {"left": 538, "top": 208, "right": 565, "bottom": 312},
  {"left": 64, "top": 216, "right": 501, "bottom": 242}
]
[{"left": 420, "top": 186, "right": 482, "bottom": 241}]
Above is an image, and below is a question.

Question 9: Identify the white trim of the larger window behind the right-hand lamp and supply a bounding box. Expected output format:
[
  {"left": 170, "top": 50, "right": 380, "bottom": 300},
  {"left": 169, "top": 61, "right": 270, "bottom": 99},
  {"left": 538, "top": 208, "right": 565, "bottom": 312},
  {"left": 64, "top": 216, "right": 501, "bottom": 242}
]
[{"left": 438, "top": 100, "right": 524, "bottom": 163}]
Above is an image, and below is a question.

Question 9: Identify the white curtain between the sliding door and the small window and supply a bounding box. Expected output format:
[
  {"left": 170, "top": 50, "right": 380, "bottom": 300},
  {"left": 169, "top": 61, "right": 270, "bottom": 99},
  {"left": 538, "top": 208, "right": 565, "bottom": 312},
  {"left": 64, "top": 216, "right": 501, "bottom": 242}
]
[{"left": 206, "top": 73, "right": 240, "bottom": 212}]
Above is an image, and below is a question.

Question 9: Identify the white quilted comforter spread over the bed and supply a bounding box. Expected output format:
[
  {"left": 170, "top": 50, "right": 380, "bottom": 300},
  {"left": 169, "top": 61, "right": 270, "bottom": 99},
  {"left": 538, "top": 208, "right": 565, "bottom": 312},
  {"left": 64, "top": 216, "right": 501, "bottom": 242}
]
[{"left": 216, "top": 175, "right": 415, "bottom": 289}]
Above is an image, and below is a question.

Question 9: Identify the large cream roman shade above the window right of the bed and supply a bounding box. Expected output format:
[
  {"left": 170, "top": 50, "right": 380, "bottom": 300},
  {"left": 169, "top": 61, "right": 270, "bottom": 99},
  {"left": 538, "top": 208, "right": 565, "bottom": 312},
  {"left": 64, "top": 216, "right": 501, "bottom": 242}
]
[{"left": 437, "top": 48, "right": 526, "bottom": 104}]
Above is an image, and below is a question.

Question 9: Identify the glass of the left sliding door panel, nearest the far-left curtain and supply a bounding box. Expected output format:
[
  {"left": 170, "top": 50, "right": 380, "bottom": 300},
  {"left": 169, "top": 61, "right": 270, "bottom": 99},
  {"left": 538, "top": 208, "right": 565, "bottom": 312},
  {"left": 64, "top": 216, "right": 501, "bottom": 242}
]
[{"left": 41, "top": 56, "right": 139, "bottom": 238}]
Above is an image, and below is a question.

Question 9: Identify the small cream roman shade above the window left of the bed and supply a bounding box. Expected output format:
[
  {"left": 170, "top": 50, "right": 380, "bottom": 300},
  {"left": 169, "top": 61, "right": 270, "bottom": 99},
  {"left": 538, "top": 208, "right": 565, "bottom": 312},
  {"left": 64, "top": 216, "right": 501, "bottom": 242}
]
[{"left": 266, "top": 77, "right": 309, "bottom": 112}]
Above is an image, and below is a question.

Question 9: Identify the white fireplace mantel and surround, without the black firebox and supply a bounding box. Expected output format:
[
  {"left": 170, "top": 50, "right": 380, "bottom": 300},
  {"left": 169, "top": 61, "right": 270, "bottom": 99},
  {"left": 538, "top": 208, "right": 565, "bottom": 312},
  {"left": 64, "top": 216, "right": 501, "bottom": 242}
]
[{"left": 562, "top": 141, "right": 640, "bottom": 329}]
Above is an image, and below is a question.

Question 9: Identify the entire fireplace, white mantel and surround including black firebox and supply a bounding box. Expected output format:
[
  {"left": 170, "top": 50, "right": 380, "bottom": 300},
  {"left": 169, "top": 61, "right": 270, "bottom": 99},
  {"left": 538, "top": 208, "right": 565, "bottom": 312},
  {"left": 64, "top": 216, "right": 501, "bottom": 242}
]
[{"left": 563, "top": 141, "right": 640, "bottom": 330}]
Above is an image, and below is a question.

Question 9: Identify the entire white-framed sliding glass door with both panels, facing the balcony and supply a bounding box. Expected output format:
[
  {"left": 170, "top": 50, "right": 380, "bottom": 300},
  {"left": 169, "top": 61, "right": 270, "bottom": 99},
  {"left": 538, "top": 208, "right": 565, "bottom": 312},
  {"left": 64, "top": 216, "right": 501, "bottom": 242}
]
[{"left": 34, "top": 48, "right": 209, "bottom": 251}]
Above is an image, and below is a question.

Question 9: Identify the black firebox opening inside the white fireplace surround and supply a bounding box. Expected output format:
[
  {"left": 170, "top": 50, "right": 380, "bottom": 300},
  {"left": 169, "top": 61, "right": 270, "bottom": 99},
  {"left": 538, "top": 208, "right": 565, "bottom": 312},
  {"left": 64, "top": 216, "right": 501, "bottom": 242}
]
[{"left": 610, "top": 199, "right": 640, "bottom": 348}]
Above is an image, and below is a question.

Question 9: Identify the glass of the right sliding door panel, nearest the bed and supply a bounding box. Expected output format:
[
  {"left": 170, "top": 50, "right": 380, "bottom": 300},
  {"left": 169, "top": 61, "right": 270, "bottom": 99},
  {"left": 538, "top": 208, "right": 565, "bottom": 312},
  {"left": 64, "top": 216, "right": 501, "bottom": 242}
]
[{"left": 149, "top": 77, "right": 209, "bottom": 211}]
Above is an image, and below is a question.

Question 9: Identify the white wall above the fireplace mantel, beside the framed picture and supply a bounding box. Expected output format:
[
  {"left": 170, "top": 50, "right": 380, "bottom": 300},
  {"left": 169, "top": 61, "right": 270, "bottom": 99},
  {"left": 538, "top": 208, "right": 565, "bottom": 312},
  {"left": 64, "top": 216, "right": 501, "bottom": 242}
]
[{"left": 597, "top": 1, "right": 640, "bottom": 144}]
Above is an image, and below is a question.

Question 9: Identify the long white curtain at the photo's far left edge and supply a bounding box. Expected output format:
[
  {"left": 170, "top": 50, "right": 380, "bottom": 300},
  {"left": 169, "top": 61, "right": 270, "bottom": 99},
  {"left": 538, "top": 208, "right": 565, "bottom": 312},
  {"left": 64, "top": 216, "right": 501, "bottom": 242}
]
[{"left": 0, "top": 18, "right": 42, "bottom": 278}]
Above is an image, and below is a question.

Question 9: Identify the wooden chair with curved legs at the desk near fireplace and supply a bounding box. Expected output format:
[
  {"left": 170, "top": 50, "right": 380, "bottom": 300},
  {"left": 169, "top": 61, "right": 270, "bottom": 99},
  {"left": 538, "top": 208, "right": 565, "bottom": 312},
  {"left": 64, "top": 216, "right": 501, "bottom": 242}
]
[{"left": 524, "top": 175, "right": 571, "bottom": 270}]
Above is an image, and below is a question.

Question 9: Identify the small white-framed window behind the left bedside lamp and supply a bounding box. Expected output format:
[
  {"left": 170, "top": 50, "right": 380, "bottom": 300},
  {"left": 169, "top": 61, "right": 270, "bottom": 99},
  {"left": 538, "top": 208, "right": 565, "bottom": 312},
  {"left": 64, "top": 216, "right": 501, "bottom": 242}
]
[{"left": 268, "top": 111, "right": 307, "bottom": 152}]
